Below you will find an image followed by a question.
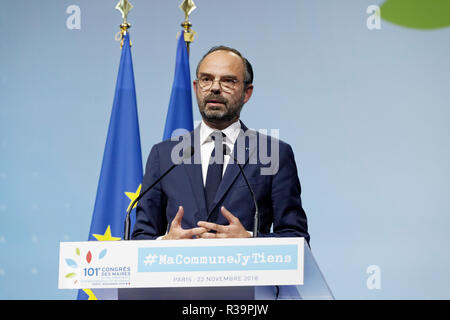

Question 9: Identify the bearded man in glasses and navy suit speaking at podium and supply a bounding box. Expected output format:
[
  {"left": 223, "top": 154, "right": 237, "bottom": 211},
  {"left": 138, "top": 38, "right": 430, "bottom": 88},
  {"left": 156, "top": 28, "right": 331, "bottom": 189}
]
[{"left": 132, "top": 46, "right": 309, "bottom": 242}]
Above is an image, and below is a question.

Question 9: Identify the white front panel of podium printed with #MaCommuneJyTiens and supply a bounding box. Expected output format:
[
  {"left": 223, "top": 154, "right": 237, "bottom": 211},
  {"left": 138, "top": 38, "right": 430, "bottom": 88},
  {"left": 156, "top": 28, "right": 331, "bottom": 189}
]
[{"left": 58, "top": 238, "right": 307, "bottom": 289}]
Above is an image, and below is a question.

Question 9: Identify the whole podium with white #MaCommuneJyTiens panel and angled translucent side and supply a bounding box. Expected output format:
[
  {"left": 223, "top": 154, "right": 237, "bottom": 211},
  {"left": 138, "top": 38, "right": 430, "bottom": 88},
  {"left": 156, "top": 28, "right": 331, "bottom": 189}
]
[{"left": 58, "top": 238, "right": 334, "bottom": 300}]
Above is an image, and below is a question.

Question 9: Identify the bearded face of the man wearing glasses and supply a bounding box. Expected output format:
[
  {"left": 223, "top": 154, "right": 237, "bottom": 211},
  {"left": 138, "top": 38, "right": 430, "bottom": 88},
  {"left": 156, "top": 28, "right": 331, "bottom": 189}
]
[{"left": 194, "top": 50, "right": 253, "bottom": 123}]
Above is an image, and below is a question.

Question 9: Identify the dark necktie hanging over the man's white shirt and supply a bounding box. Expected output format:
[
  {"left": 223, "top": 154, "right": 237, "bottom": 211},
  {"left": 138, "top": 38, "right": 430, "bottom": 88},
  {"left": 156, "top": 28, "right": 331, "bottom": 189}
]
[{"left": 205, "top": 131, "right": 225, "bottom": 211}]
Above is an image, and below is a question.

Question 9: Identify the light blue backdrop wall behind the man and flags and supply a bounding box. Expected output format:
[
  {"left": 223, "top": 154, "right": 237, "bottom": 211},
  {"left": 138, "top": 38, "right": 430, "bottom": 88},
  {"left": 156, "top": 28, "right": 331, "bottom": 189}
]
[{"left": 0, "top": 0, "right": 450, "bottom": 299}]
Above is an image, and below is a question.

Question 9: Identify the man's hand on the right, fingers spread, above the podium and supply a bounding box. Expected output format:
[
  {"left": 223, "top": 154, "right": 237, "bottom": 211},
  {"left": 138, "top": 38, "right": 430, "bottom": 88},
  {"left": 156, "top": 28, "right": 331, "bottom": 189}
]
[{"left": 197, "top": 207, "right": 251, "bottom": 239}]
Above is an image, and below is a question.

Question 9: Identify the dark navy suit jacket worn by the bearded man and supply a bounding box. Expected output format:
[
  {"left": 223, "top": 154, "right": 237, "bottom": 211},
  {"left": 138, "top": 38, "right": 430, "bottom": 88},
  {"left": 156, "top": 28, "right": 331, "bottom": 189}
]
[{"left": 132, "top": 122, "right": 309, "bottom": 243}]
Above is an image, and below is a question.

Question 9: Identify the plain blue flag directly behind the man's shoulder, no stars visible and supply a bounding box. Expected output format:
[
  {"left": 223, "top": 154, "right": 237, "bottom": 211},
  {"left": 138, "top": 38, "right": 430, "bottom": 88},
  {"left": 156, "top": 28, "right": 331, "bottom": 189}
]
[{"left": 163, "top": 31, "right": 194, "bottom": 140}]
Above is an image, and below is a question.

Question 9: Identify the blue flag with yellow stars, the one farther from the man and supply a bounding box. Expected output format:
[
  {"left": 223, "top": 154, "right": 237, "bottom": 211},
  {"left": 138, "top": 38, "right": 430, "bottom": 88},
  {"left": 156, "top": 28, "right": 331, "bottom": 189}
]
[{"left": 78, "top": 33, "right": 142, "bottom": 300}]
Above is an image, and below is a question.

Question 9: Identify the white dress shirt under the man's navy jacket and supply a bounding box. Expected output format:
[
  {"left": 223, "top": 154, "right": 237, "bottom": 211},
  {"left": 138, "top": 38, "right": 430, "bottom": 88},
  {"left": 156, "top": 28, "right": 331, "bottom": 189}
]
[{"left": 200, "top": 120, "right": 241, "bottom": 186}]
